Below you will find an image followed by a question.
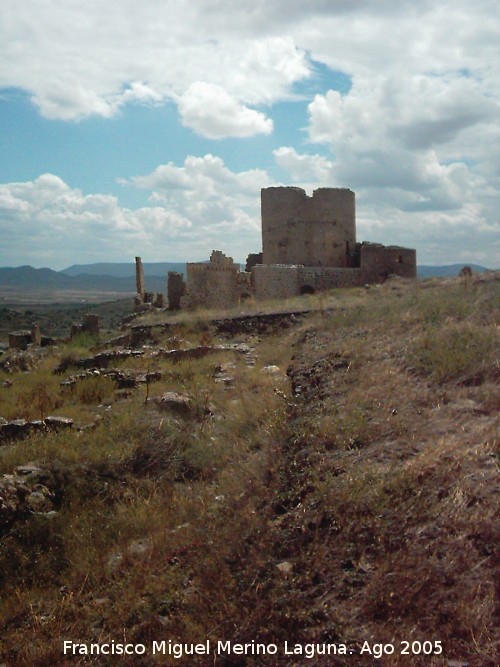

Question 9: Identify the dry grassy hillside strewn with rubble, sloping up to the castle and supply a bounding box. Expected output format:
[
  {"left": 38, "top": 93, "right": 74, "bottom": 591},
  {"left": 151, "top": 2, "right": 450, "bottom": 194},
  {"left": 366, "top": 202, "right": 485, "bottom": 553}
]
[{"left": 0, "top": 273, "right": 500, "bottom": 667}]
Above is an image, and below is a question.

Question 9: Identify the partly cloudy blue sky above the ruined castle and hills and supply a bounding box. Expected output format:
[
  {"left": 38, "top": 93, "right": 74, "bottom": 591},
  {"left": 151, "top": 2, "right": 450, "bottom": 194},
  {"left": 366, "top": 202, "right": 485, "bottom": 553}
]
[{"left": 0, "top": 0, "right": 500, "bottom": 269}]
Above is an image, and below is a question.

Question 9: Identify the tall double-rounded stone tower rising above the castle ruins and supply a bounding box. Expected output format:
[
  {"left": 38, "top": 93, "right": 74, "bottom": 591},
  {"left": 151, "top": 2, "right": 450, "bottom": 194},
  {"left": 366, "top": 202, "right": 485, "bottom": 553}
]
[{"left": 261, "top": 187, "right": 356, "bottom": 267}]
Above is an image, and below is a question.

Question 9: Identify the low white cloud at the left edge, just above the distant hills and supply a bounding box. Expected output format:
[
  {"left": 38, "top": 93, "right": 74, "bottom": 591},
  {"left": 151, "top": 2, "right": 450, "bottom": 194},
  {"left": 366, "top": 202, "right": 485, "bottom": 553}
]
[{"left": 0, "top": 174, "right": 191, "bottom": 268}]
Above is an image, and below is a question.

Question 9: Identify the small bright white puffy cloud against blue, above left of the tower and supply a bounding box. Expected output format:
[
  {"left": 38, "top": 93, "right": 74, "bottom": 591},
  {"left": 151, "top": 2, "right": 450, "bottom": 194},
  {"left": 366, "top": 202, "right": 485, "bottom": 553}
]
[{"left": 179, "top": 81, "right": 273, "bottom": 139}]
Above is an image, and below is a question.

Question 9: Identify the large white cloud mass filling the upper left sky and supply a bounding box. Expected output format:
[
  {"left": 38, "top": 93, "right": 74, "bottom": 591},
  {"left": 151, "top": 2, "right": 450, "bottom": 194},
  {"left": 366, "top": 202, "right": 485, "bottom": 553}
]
[{"left": 0, "top": 0, "right": 311, "bottom": 132}]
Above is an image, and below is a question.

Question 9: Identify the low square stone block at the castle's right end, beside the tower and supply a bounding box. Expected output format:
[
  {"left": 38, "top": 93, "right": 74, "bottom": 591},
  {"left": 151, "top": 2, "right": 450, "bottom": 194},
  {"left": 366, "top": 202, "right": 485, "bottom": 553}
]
[{"left": 360, "top": 243, "right": 417, "bottom": 283}]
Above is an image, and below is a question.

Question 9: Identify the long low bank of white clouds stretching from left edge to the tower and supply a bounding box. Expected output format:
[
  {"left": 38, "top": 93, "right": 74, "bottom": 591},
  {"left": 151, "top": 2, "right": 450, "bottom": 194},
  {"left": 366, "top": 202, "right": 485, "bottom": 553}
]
[{"left": 0, "top": 155, "right": 270, "bottom": 268}]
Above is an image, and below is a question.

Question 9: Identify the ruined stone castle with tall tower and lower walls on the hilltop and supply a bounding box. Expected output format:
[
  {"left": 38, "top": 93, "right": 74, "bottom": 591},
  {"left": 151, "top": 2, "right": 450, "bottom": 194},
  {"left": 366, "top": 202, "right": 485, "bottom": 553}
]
[{"left": 135, "top": 187, "right": 417, "bottom": 309}]
